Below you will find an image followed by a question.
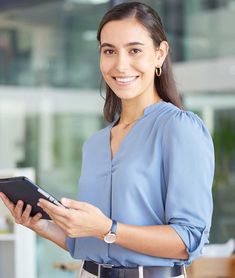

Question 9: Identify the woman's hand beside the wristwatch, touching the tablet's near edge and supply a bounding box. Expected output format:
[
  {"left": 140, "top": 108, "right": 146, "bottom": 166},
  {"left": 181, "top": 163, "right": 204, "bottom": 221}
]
[{"left": 38, "top": 198, "right": 112, "bottom": 239}]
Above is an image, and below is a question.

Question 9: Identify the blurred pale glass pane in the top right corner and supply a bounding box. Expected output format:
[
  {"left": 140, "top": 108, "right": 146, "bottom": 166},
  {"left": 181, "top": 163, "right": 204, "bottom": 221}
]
[{"left": 184, "top": 0, "right": 235, "bottom": 60}]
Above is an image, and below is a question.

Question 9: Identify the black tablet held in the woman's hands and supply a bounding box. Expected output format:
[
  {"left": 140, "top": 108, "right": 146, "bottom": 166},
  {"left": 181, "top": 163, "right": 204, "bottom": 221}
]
[{"left": 0, "top": 177, "right": 63, "bottom": 219}]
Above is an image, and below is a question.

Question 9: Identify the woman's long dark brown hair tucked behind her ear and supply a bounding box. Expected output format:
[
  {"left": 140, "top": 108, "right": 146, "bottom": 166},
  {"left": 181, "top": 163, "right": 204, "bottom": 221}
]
[{"left": 97, "top": 2, "right": 181, "bottom": 122}]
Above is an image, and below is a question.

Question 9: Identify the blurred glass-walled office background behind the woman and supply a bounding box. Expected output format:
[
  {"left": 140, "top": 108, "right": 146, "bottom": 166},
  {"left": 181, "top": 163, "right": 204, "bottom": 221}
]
[{"left": 0, "top": 0, "right": 235, "bottom": 278}]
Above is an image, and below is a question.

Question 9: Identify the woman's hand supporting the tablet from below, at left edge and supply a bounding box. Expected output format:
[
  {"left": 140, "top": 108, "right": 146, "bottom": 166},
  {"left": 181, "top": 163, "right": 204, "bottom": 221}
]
[{"left": 0, "top": 192, "right": 49, "bottom": 235}]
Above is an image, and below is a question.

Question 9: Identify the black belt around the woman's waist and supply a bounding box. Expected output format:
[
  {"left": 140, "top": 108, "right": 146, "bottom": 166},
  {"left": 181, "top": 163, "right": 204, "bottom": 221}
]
[{"left": 83, "top": 261, "right": 184, "bottom": 278}]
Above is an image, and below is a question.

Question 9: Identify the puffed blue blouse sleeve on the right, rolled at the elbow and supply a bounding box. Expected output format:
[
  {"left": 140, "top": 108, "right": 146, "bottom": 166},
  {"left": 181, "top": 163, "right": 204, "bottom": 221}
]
[{"left": 162, "top": 111, "right": 214, "bottom": 264}]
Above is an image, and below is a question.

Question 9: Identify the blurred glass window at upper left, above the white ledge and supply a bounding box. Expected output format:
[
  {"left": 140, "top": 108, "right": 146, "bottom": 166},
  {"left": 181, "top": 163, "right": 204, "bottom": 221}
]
[{"left": 0, "top": 0, "right": 108, "bottom": 88}]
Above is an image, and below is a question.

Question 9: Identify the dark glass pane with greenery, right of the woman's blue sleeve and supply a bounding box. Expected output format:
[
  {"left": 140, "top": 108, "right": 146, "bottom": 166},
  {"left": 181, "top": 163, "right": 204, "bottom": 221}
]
[{"left": 211, "top": 108, "right": 235, "bottom": 242}]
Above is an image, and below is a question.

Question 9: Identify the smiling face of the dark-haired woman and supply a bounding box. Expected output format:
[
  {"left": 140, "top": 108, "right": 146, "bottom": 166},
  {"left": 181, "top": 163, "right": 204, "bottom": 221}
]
[{"left": 100, "top": 18, "right": 165, "bottom": 100}]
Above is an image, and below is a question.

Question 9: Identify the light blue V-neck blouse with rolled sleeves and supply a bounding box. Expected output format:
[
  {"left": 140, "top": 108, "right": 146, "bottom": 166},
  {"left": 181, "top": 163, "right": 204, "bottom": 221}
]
[{"left": 67, "top": 101, "right": 214, "bottom": 267}]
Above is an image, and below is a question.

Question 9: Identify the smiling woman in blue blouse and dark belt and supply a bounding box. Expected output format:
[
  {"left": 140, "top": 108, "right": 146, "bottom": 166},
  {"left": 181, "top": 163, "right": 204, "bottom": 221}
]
[{"left": 1, "top": 2, "right": 214, "bottom": 278}]
